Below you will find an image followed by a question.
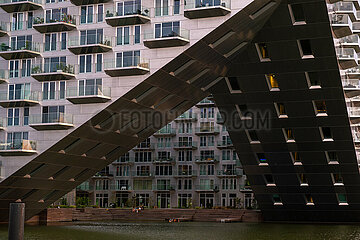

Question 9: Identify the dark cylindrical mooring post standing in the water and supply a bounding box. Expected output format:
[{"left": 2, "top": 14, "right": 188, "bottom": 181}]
[{"left": 9, "top": 203, "right": 25, "bottom": 240}]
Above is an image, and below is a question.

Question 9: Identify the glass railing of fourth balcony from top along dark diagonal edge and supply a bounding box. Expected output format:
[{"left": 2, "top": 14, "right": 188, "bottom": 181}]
[{"left": 66, "top": 85, "right": 111, "bottom": 97}]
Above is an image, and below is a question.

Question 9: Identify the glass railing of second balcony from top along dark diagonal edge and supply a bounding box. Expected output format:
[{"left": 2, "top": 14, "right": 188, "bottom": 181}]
[{"left": 144, "top": 27, "right": 190, "bottom": 40}]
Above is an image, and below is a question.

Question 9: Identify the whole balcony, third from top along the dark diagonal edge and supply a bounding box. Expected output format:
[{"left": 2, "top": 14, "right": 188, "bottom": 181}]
[{"left": 104, "top": 57, "right": 150, "bottom": 77}]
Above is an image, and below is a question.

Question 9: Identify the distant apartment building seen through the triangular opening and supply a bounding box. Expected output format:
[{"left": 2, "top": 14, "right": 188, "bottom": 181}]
[{"left": 75, "top": 98, "right": 255, "bottom": 208}]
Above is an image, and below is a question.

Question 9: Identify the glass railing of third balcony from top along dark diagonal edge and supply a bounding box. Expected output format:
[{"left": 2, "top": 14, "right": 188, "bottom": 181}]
[{"left": 104, "top": 56, "right": 150, "bottom": 69}]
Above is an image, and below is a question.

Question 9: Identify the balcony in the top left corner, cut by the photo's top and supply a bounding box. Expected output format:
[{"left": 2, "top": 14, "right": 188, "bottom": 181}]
[{"left": 0, "top": 0, "right": 43, "bottom": 13}]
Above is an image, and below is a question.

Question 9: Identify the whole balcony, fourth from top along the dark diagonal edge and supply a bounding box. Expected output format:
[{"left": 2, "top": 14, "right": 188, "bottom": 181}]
[{"left": 66, "top": 86, "right": 111, "bottom": 104}]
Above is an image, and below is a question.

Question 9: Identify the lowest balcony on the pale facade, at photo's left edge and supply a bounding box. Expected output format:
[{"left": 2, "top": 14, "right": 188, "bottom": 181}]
[{"left": 0, "top": 139, "right": 36, "bottom": 156}]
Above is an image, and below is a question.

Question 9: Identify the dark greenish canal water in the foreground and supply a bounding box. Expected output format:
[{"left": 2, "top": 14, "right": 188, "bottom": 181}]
[{"left": 0, "top": 222, "right": 360, "bottom": 240}]
